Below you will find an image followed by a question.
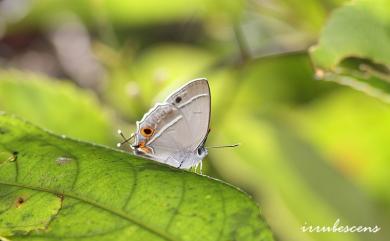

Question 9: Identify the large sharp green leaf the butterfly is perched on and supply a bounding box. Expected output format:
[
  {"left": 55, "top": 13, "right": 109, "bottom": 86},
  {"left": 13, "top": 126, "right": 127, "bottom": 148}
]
[{"left": 0, "top": 114, "right": 273, "bottom": 241}]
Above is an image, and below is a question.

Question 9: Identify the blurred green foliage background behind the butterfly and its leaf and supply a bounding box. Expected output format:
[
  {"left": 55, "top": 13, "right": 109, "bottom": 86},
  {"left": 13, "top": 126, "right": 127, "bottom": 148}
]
[{"left": 0, "top": 0, "right": 390, "bottom": 241}]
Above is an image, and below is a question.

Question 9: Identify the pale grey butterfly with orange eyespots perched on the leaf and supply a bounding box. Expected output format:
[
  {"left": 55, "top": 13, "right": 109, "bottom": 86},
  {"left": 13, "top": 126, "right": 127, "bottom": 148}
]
[{"left": 118, "top": 79, "right": 236, "bottom": 169}]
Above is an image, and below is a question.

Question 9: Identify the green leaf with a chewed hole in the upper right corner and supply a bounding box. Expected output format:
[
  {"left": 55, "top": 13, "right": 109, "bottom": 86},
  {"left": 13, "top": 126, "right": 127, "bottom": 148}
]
[{"left": 310, "top": 0, "right": 390, "bottom": 103}]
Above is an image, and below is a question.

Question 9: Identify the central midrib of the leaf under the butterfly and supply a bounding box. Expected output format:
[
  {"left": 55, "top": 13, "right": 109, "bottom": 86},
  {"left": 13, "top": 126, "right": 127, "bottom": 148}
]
[{"left": 0, "top": 181, "right": 181, "bottom": 241}]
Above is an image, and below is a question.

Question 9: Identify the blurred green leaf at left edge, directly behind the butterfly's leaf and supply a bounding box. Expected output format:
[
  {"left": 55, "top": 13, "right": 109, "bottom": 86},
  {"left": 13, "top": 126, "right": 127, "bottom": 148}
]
[{"left": 0, "top": 70, "right": 114, "bottom": 144}]
